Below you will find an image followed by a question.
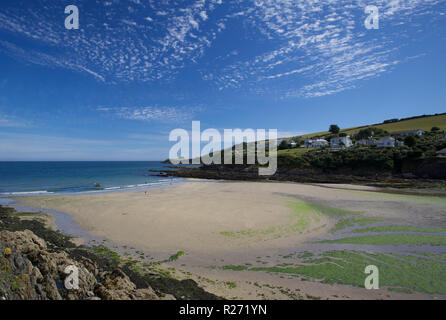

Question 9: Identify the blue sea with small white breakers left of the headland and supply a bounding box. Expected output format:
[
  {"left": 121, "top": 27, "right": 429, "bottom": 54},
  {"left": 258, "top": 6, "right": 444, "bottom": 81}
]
[{"left": 0, "top": 161, "right": 179, "bottom": 196}]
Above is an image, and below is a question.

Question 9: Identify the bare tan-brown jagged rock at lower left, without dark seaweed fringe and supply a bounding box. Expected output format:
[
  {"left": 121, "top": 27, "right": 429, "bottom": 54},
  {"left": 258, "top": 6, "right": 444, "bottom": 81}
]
[{"left": 0, "top": 230, "right": 175, "bottom": 300}]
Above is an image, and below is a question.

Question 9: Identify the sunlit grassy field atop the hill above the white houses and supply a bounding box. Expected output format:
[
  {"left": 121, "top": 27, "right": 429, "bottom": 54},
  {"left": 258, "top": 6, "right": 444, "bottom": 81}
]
[{"left": 302, "top": 114, "right": 446, "bottom": 138}]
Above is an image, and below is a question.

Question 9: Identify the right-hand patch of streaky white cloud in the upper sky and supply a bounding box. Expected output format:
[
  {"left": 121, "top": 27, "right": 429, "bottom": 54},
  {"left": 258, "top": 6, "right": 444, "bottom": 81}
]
[{"left": 203, "top": 0, "right": 445, "bottom": 98}]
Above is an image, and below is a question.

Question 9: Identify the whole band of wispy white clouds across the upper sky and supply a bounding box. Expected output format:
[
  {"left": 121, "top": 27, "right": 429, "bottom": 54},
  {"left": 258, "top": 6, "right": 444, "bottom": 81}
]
[{"left": 0, "top": 0, "right": 446, "bottom": 98}]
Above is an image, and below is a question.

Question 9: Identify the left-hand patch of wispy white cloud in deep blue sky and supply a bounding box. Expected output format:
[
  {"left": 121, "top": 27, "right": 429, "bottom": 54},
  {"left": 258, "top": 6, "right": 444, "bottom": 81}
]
[{"left": 0, "top": 0, "right": 221, "bottom": 82}]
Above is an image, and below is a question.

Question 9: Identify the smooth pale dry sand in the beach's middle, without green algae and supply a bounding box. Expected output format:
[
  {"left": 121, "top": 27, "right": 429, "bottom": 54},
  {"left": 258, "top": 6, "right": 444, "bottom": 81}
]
[{"left": 15, "top": 181, "right": 330, "bottom": 255}]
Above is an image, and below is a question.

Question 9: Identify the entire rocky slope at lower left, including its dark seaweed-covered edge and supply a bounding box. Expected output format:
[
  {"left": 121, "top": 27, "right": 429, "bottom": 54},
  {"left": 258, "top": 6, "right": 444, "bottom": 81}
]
[{"left": 0, "top": 206, "right": 216, "bottom": 300}]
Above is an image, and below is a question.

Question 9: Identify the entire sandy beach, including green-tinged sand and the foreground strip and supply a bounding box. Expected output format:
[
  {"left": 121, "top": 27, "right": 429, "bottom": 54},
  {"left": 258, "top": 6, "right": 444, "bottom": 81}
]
[{"left": 13, "top": 180, "right": 446, "bottom": 299}]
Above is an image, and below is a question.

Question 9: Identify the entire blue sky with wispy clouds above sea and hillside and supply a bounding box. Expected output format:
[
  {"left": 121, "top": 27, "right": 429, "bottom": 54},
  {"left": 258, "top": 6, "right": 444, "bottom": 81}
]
[{"left": 0, "top": 0, "right": 446, "bottom": 160}]
